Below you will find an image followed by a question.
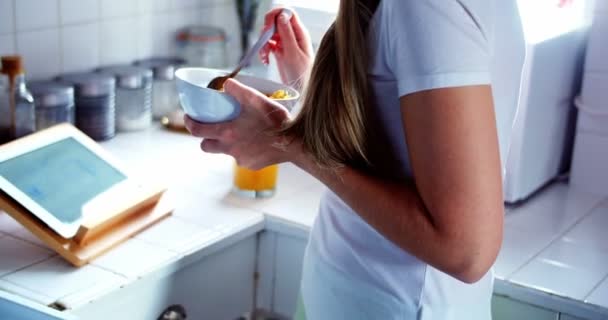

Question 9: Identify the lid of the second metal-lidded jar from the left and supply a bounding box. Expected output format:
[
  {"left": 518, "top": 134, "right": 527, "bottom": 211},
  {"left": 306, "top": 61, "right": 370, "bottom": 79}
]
[{"left": 57, "top": 72, "right": 116, "bottom": 98}]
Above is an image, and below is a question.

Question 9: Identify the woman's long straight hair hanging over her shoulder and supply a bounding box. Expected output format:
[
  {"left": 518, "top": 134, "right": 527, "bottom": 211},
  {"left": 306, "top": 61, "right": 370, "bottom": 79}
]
[{"left": 281, "top": 0, "right": 379, "bottom": 167}]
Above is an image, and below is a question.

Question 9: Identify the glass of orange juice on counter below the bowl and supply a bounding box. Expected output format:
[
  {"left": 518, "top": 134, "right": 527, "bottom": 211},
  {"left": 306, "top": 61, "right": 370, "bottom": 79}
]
[{"left": 234, "top": 164, "right": 279, "bottom": 198}]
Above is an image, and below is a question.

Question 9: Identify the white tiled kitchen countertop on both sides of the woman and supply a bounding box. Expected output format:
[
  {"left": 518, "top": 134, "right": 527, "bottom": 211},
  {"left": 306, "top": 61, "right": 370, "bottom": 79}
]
[{"left": 0, "top": 127, "right": 608, "bottom": 318}]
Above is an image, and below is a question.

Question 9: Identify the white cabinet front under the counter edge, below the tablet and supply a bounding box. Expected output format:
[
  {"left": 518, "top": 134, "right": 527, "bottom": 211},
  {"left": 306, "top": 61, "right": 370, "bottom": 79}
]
[{"left": 72, "top": 235, "right": 256, "bottom": 320}]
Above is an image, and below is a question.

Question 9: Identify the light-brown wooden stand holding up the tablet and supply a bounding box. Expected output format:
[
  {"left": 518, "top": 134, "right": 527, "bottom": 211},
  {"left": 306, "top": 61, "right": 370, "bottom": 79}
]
[{"left": 0, "top": 190, "right": 173, "bottom": 267}]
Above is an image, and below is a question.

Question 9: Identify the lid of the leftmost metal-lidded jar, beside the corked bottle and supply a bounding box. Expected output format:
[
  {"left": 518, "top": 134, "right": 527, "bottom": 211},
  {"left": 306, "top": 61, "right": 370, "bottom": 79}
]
[{"left": 27, "top": 81, "right": 74, "bottom": 108}]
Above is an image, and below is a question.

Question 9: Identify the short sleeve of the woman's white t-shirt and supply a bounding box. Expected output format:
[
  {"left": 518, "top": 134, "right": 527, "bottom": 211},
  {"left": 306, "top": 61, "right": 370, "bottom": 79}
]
[{"left": 384, "top": 0, "right": 493, "bottom": 96}]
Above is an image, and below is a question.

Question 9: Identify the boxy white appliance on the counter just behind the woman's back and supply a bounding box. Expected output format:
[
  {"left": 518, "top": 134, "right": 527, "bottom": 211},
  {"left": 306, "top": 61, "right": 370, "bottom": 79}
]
[{"left": 504, "top": 0, "right": 590, "bottom": 203}]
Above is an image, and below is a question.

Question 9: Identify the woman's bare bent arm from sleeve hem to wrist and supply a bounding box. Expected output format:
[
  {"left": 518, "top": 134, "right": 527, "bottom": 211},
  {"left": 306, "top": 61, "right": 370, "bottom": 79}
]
[{"left": 293, "top": 86, "right": 503, "bottom": 282}]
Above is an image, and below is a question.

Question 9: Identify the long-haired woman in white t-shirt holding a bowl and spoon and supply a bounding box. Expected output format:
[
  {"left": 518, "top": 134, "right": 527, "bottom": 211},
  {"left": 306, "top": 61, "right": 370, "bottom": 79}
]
[{"left": 186, "top": 0, "right": 523, "bottom": 320}]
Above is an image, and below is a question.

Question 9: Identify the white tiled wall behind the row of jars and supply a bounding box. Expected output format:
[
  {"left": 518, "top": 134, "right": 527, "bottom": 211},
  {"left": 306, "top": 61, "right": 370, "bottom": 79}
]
[{"left": 0, "top": 0, "right": 240, "bottom": 78}]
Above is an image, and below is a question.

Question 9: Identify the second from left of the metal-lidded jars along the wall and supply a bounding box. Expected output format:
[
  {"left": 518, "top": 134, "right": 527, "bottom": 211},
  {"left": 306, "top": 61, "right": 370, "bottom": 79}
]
[{"left": 59, "top": 73, "right": 116, "bottom": 141}]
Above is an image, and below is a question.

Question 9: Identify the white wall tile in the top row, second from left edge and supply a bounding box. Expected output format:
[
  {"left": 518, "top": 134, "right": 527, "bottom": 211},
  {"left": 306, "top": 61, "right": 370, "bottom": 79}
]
[{"left": 15, "top": 0, "right": 59, "bottom": 31}]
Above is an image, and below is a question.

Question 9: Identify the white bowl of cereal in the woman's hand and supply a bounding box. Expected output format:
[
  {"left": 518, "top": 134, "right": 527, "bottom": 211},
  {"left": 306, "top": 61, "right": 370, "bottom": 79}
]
[{"left": 175, "top": 68, "right": 300, "bottom": 123}]
